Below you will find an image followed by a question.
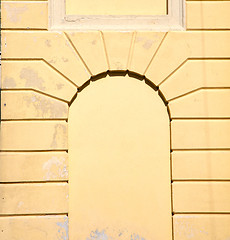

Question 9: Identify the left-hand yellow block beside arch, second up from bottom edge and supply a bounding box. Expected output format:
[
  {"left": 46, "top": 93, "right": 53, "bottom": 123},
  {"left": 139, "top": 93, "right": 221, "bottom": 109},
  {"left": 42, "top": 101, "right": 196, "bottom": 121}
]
[{"left": 0, "top": 183, "right": 68, "bottom": 215}]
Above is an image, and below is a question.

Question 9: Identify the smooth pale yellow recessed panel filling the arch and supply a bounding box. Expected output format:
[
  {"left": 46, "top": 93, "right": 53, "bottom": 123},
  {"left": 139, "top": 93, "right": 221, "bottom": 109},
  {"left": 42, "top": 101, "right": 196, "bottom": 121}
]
[{"left": 69, "top": 76, "right": 172, "bottom": 240}]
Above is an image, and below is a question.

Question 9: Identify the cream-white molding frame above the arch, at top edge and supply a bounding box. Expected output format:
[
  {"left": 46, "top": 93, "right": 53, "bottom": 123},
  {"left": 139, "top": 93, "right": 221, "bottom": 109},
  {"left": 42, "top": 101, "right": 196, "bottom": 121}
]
[{"left": 49, "top": 0, "right": 185, "bottom": 32}]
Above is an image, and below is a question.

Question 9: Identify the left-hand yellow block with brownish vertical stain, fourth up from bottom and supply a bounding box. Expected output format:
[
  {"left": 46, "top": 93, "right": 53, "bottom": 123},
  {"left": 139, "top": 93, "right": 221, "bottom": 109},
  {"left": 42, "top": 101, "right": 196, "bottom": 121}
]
[{"left": 0, "top": 121, "right": 68, "bottom": 151}]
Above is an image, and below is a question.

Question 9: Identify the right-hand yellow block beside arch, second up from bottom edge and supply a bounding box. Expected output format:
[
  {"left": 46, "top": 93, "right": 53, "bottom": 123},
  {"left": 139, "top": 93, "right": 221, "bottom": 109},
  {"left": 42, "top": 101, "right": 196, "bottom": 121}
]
[{"left": 173, "top": 182, "right": 230, "bottom": 213}]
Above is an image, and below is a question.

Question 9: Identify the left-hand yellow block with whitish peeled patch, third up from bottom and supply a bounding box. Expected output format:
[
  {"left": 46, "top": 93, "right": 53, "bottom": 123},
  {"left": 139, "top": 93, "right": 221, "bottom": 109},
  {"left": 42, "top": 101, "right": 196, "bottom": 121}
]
[{"left": 0, "top": 152, "right": 68, "bottom": 182}]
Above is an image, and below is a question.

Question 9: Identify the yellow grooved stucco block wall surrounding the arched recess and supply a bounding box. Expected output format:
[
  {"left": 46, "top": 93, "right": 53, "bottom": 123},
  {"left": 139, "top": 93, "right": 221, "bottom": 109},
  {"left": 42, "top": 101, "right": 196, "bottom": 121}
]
[{"left": 0, "top": 0, "right": 230, "bottom": 240}]
